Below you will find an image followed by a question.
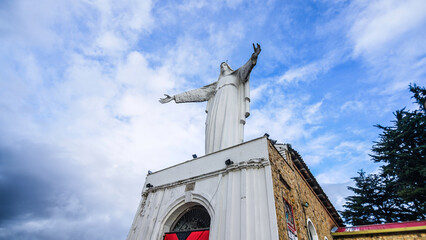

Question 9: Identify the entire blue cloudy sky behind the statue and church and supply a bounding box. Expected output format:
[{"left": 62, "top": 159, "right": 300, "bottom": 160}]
[{"left": 0, "top": 0, "right": 426, "bottom": 239}]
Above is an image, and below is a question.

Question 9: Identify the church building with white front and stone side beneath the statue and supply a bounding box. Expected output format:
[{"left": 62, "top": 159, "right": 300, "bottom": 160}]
[{"left": 127, "top": 137, "right": 426, "bottom": 240}]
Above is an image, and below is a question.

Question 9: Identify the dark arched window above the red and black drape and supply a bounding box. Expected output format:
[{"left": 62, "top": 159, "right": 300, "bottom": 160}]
[{"left": 171, "top": 205, "right": 210, "bottom": 232}]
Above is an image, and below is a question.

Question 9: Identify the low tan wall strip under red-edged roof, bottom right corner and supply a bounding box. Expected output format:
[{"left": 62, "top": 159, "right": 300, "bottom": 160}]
[{"left": 334, "top": 231, "right": 426, "bottom": 240}]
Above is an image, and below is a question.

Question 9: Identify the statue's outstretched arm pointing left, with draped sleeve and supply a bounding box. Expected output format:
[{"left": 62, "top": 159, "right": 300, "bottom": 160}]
[{"left": 159, "top": 82, "right": 217, "bottom": 104}]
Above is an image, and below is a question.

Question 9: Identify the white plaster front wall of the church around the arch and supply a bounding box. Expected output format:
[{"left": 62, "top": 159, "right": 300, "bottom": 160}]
[{"left": 127, "top": 138, "right": 278, "bottom": 240}]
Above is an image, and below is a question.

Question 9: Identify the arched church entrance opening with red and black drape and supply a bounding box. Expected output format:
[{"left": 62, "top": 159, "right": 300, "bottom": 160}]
[{"left": 164, "top": 203, "right": 211, "bottom": 240}]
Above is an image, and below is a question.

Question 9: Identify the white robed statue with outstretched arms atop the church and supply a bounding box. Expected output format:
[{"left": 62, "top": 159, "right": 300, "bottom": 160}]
[{"left": 160, "top": 44, "right": 261, "bottom": 154}]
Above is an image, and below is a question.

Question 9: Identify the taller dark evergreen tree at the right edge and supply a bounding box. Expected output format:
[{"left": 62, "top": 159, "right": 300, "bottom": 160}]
[{"left": 371, "top": 85, "right": 426, "bottom": 220}]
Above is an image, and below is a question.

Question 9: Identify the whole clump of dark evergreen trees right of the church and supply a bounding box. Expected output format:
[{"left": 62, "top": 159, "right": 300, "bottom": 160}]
[{"left": 341, "top": 84, "right": 426, "bottom": 225}]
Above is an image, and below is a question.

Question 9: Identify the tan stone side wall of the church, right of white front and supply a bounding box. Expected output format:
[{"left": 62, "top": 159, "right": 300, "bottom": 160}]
[{"left": 268, "top": 142, "right": 337, "bottom": 240}]
